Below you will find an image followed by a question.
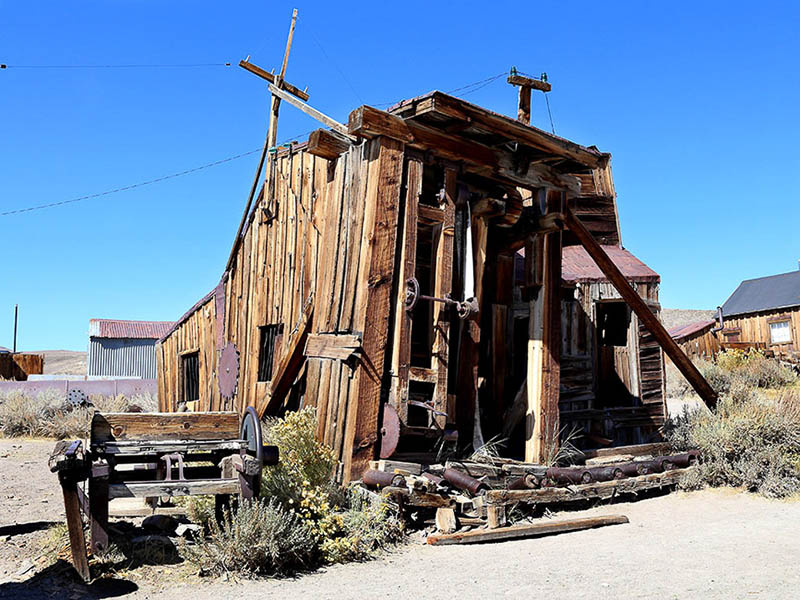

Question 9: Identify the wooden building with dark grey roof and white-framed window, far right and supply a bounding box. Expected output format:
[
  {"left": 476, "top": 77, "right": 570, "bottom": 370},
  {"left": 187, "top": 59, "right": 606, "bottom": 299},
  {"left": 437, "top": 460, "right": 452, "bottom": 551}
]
[{"left": 719, "top": 270, "right": 800, "bottom": 358}]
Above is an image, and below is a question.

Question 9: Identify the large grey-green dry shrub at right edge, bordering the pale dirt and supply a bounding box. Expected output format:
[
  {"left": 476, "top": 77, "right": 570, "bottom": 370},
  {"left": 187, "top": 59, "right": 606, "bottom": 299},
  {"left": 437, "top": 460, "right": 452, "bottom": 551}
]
[{"left": 668, "top": 387, "right": 800, "bottom": 498}]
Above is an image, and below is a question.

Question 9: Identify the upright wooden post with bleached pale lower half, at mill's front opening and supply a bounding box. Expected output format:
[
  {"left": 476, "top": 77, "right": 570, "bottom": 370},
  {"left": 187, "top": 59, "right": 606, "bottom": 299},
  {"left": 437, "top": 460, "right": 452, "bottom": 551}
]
[{"left": 525, "top": 190, "right": 566, "bottom": 464}]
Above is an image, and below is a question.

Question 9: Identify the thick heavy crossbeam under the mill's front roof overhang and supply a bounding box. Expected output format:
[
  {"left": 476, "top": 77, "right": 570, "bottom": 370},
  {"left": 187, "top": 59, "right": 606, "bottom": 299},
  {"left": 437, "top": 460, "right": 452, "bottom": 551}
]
[{"left": 348, "top": 106, "right": 580, "bottom": 194}]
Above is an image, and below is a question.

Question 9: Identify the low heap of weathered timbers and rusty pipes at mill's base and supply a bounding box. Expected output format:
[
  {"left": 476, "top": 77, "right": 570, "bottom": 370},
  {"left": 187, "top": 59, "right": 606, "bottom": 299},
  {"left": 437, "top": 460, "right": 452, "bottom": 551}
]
[{"left": 361, "top": 444, "right": 699, "bottom": 544}]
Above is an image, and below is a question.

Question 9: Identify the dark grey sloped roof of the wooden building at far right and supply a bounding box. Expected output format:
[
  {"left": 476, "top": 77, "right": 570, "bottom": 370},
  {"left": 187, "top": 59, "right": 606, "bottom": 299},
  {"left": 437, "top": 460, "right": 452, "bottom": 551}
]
[{"left": 722, "top": 271, "right": 800, "bottom": 317}]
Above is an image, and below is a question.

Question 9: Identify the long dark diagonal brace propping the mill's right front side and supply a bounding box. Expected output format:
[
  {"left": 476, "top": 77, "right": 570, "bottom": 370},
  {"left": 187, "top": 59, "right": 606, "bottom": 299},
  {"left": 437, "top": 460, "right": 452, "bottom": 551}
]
[{"left": 564, "top": 208, "right": 717, "bottom": 408}]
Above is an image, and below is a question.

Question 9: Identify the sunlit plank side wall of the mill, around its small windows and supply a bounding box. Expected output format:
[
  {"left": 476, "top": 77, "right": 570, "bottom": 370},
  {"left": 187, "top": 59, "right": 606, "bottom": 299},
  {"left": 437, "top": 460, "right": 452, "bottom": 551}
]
[{"left": 158, "top": 145, "right": 332, "bottom": 412}]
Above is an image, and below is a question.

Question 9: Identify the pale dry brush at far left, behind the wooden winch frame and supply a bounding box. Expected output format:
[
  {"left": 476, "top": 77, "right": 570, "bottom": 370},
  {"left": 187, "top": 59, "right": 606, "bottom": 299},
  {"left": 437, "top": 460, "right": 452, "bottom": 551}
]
[{"left": 0, "top": 390, "right": 157, "bottom": 439}]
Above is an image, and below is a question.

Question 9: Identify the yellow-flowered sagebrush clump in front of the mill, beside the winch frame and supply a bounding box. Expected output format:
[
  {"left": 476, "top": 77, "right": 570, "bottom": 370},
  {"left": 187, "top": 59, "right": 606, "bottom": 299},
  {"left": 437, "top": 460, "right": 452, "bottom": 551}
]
[{"left": 186, "top": 408, "right": 404, "bottom": 576}]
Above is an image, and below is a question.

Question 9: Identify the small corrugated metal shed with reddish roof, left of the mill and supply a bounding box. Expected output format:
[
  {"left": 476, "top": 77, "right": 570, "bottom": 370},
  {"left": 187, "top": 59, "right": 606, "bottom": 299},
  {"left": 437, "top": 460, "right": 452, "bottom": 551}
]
[{"left": 86, "top": 319, "right": 173, "bottom": 379}]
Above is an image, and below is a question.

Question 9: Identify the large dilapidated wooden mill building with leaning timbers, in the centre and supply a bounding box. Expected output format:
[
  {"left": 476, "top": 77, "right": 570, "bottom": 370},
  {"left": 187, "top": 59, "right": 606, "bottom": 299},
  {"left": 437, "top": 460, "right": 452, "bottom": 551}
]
[{"left": 157, "top": 11, "right": 715, "bottom": 481}]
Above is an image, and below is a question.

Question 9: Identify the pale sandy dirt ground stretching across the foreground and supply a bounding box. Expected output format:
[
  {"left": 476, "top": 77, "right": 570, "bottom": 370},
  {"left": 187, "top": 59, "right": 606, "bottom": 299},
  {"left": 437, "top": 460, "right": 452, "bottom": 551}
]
[{"left": 0, "top": 439, "right": 800, "bottom": 600}]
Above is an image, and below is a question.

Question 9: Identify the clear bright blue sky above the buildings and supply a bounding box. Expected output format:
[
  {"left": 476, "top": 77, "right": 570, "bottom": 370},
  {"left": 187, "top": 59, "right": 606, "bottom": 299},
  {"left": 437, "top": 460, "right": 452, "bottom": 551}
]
[{"left": 0, "top": 0, "right": 800, "bottom": 350}]
